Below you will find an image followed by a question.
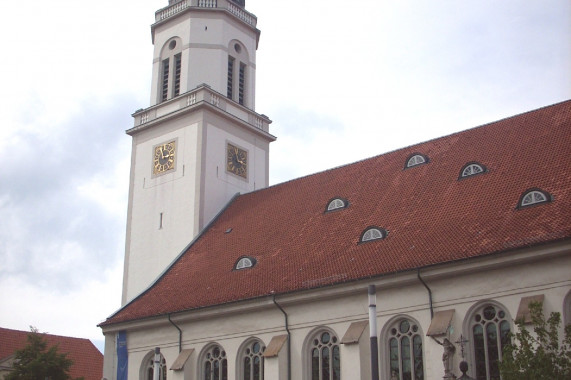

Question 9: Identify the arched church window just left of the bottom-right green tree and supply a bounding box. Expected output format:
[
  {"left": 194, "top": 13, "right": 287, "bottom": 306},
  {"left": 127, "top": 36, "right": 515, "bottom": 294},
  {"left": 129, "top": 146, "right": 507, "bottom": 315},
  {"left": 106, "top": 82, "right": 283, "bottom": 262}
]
[{"left": 470, "top": 305, "right": 510, "bottom": 380}]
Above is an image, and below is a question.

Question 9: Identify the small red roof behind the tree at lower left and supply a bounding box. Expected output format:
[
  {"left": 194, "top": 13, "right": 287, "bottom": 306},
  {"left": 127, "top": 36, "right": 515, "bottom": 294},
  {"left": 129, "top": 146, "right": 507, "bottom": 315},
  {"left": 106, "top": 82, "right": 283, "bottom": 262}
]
[{"left": 0, "top": 327, "right": 103, "bottom": 380}]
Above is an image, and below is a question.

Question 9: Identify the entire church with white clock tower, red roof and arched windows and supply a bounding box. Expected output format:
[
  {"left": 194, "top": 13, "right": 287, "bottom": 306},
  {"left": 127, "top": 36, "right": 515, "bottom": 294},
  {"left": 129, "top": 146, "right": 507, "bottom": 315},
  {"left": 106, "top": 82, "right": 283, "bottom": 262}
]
[{"left": 100, "top": 0, "right": 571, "bottom": 380}]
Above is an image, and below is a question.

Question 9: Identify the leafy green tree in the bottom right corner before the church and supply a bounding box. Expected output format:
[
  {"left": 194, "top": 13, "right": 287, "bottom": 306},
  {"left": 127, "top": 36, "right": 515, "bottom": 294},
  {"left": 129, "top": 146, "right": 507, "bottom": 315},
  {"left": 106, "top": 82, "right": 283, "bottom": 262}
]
[{"left": 500, "top": 302, "right": 571, "bottom": 380}]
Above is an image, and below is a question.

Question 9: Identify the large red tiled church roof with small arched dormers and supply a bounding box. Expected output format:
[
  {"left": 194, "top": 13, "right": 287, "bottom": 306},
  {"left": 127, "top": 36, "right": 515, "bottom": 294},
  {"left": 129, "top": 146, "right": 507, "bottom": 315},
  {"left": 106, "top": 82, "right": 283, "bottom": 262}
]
[{"left": 102, "top": 101, "right": 571, "bottom": 325}]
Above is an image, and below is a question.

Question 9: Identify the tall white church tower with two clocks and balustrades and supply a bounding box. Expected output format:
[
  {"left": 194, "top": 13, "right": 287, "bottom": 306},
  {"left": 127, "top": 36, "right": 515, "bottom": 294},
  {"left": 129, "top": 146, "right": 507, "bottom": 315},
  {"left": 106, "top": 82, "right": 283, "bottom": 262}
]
[{"left": 122, "top": 0, "right": 275, "bottom": 305}]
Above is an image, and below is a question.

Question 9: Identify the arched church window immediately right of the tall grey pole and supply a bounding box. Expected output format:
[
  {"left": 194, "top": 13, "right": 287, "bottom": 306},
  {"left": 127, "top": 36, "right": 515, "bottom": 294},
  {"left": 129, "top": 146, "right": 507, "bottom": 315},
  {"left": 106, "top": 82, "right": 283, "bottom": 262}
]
[{"left": 382, "top": 318, "right": 424, "bottom": 380}]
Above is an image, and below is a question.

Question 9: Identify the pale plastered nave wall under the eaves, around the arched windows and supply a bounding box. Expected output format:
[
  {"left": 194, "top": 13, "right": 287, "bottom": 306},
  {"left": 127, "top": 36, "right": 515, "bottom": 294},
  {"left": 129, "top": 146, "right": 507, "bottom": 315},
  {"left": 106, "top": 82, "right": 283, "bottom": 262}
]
[{"left": 106, "top": 245, "right": 571, "bottom": 380}]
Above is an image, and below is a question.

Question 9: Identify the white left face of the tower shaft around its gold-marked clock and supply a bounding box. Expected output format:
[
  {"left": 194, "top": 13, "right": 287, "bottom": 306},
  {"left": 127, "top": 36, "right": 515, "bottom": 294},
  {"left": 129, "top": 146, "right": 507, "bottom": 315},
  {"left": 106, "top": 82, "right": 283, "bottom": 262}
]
[{"left": 124, "top": 119, "right": 200, "bottom": 302}]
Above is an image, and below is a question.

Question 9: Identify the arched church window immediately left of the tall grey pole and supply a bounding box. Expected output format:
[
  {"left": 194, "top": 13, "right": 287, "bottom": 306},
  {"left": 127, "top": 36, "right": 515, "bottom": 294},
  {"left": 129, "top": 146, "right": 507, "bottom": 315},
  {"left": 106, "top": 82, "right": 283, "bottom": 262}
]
[{"left": 311, "top": 331, "right": 341, "bottom": 380}]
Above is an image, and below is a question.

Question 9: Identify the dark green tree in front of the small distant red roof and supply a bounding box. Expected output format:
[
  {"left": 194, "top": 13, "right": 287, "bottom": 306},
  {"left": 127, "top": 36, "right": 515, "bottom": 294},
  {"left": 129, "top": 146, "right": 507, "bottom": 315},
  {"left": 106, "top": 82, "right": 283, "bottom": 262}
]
[{"left": 5, "top": 327, "right": 81, "bottom": 380}]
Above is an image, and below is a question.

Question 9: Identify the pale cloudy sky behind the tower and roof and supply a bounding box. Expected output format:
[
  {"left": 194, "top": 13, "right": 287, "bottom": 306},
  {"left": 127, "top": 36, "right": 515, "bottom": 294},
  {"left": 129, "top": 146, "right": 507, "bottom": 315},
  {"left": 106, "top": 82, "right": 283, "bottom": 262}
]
[{"left": 0, "top": 0, "right": 571, "bottom": 345}]
